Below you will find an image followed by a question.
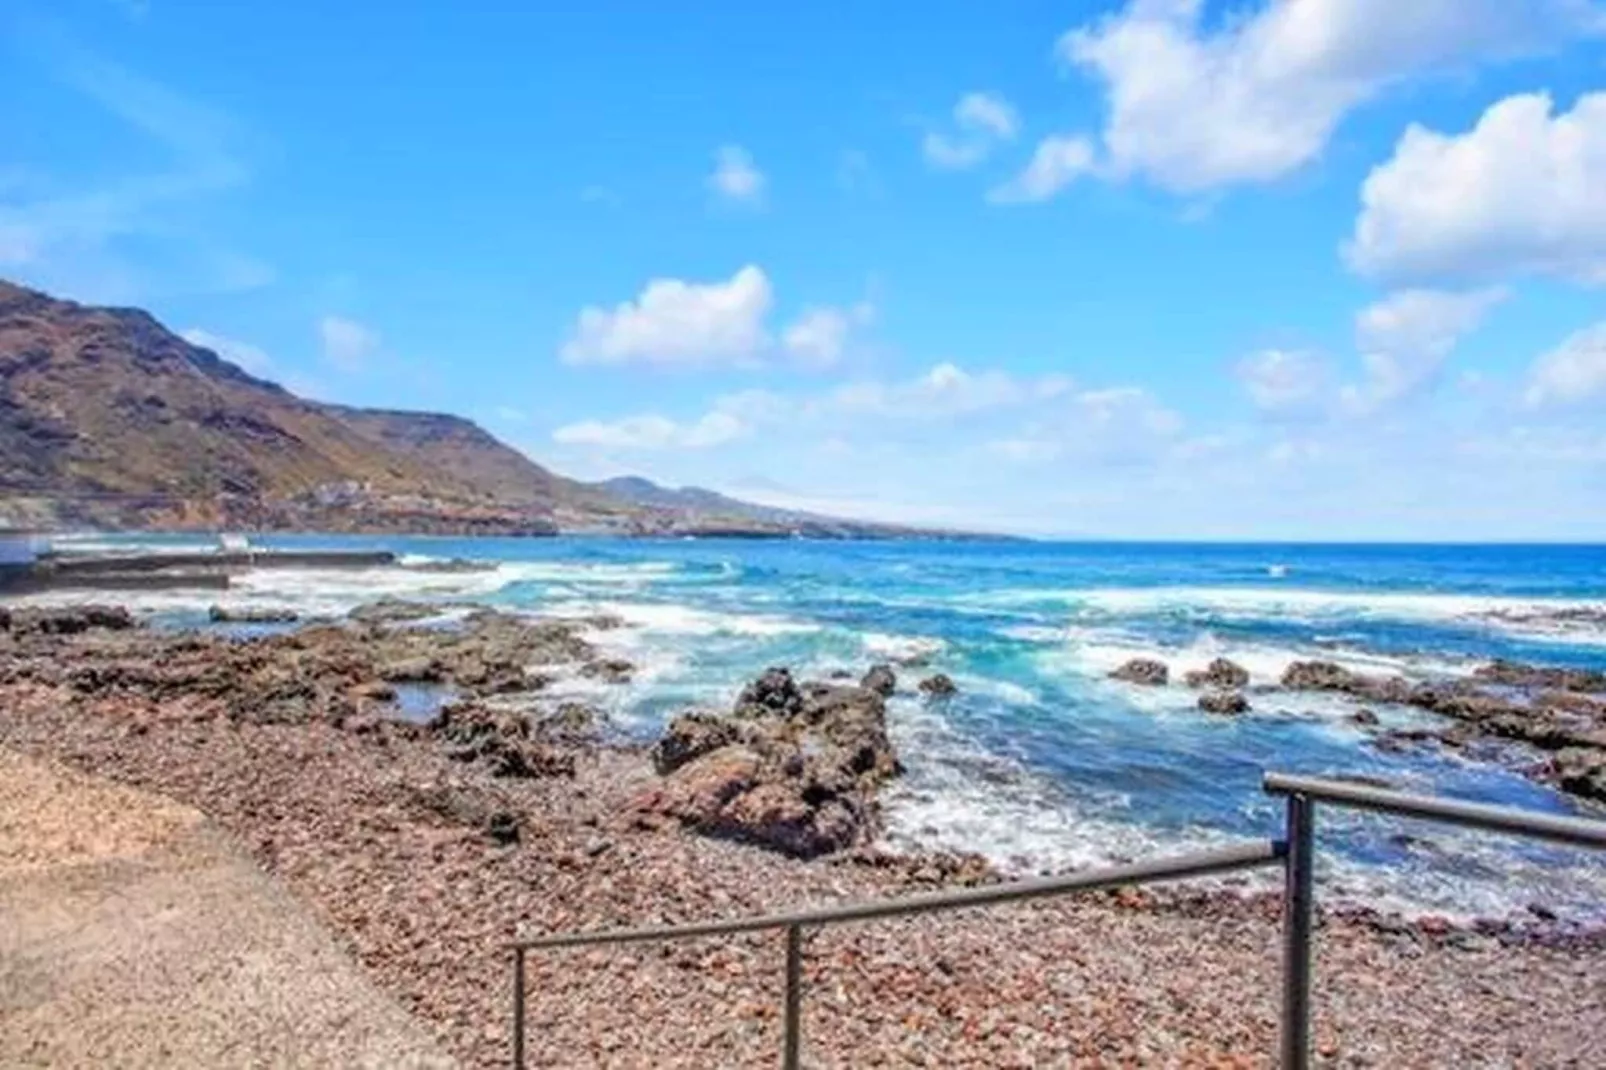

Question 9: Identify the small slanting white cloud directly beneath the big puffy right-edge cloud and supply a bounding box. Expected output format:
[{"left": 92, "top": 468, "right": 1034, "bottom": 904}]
[{"left": 1343, "top": 288, "right": 1508, "bottom": 413}]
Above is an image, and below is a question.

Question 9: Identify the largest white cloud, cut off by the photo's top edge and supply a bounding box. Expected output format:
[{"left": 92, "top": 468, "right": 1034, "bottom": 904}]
[{"left": 1058, "top": 0, "right": 1603, "bottom": 193}]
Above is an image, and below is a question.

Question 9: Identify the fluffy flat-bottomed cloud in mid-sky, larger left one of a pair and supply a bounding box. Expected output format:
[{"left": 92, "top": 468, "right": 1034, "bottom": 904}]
[{"left": 562, "top": 265, "right": 774, "bottom": 368}]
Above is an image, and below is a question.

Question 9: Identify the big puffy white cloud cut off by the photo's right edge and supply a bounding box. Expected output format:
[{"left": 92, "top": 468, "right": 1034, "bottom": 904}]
[{"left": 1346, "top": 93, "right": 1606, "bottom": 283}]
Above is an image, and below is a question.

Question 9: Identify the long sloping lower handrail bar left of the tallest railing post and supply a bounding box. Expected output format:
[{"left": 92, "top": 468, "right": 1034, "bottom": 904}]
[{"left": 511, "top": 840, "right": 1283, "bottom": 950}]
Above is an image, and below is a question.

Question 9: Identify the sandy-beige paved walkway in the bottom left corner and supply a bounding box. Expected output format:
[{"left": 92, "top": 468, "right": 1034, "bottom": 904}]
[{"left": 0, "top": 750, "right": 454, "bottom": 1070}]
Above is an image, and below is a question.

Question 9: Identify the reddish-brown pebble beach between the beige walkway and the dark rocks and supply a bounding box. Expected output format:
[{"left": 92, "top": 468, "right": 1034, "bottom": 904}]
[{"left": 0, "top": 683, "right": 1606, "bottom": 1067}]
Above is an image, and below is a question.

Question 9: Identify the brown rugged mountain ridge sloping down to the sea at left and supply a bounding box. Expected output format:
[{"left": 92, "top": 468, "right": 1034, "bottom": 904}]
[{"left": 0, "top": 281, "right": 976, "bottom": 537}]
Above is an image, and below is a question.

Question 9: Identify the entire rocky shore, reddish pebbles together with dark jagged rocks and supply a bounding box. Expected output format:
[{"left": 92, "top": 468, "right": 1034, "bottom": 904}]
[{"left": 0, "top": 602, "right": 1606, "bottom": 1067}]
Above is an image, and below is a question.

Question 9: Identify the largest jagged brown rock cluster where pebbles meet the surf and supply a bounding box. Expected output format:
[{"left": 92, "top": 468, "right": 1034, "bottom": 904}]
[{"left": 636, "top": 668, "right": 901, "bottom": 858}]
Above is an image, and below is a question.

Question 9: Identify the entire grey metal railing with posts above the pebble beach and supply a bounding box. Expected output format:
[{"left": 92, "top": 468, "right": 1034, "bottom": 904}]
[{"left": 511, "top": 773, "right": 1606, "bottom": 1070}]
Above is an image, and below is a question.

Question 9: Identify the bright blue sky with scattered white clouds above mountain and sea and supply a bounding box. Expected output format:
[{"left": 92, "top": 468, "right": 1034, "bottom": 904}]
[{"left": 0, "top": 0, "right": 1606, "bottom": 541}]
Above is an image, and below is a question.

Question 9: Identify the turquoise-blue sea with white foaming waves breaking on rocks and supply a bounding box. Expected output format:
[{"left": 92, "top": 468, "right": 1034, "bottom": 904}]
[{"left": 34, "top": 537, "right": 1606, "bottom": 916}]
